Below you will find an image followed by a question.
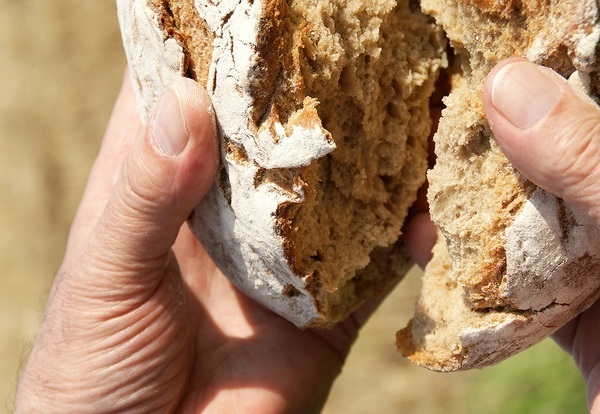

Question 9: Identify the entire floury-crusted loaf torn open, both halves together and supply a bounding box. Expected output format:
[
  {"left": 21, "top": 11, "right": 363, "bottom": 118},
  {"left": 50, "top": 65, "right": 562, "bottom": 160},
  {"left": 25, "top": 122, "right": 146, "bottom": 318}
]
[{"left": 117, "top": 0, "right": 600, "bottom": 371}]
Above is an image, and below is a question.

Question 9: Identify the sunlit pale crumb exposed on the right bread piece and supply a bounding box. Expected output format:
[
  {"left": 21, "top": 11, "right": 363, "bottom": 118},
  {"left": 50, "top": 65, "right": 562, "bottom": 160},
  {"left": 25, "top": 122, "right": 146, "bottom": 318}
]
[{"left": 397, "top": 0, "right": 539, "bottom": 371}]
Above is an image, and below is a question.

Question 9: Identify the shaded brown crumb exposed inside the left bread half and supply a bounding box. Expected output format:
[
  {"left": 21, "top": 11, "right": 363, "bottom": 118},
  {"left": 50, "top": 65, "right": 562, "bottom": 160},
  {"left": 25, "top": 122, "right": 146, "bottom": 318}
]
[{"left": 283, "top": 0, "right": 441, "bottom": 312}]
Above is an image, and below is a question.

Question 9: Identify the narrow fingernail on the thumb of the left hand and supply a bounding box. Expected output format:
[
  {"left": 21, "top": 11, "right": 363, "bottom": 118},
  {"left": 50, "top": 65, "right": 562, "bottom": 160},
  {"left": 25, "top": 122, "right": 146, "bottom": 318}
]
[{"left": 152, "top": 87, "right": 188, "bottom": 156}]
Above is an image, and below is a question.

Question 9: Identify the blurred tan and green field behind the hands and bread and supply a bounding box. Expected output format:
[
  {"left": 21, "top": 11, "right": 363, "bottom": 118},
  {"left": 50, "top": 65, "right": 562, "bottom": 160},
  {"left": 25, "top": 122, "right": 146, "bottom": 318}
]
[{"left": 0, "top": 0, "right": 587, "bottom": 414}]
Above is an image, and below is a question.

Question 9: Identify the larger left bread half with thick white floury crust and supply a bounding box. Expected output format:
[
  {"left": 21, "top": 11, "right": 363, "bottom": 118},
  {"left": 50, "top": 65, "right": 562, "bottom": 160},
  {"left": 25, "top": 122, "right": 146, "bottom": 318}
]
[{"left": 117, "top": 0, "right": 444, "bottom": 327}]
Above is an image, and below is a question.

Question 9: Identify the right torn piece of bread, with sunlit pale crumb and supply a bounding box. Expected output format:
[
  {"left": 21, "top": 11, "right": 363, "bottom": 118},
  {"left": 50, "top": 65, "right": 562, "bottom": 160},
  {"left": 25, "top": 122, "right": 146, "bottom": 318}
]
[{"left": 397, "top": 0, "right": 600, "bottom": 371}]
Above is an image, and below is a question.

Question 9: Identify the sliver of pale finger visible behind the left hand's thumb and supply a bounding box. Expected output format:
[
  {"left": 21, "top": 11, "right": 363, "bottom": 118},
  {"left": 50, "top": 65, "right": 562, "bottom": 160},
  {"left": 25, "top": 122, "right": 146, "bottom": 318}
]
[{"left": 67, "top": 70, "right": 143, "bottom": 252}]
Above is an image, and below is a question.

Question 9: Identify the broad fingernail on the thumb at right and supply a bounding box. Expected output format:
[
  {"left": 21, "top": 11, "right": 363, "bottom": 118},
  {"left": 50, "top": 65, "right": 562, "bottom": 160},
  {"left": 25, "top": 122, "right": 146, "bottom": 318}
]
[{"left": 492, "top": 62, "right": 561, "bottom": 129}]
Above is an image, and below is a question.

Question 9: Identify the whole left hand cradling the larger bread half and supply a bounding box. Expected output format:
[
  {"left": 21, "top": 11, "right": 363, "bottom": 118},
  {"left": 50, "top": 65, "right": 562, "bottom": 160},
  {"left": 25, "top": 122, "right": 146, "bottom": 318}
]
[{"left": 15, "top": 73, "right": 410, "bottom": 413}]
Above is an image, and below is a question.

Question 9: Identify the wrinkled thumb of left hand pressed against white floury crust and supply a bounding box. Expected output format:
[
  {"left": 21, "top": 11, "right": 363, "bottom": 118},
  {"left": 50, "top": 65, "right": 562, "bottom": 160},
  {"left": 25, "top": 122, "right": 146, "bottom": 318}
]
[{"left": 77, "top": 79, "right": 218, "bottom": 288}]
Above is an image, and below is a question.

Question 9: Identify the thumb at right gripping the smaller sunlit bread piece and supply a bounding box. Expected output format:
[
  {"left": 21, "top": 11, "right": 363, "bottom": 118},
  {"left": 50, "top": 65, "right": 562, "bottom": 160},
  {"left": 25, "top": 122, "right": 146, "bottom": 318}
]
[{"left": 483, "top": 59, "right": 600, "bottom": 226}]
